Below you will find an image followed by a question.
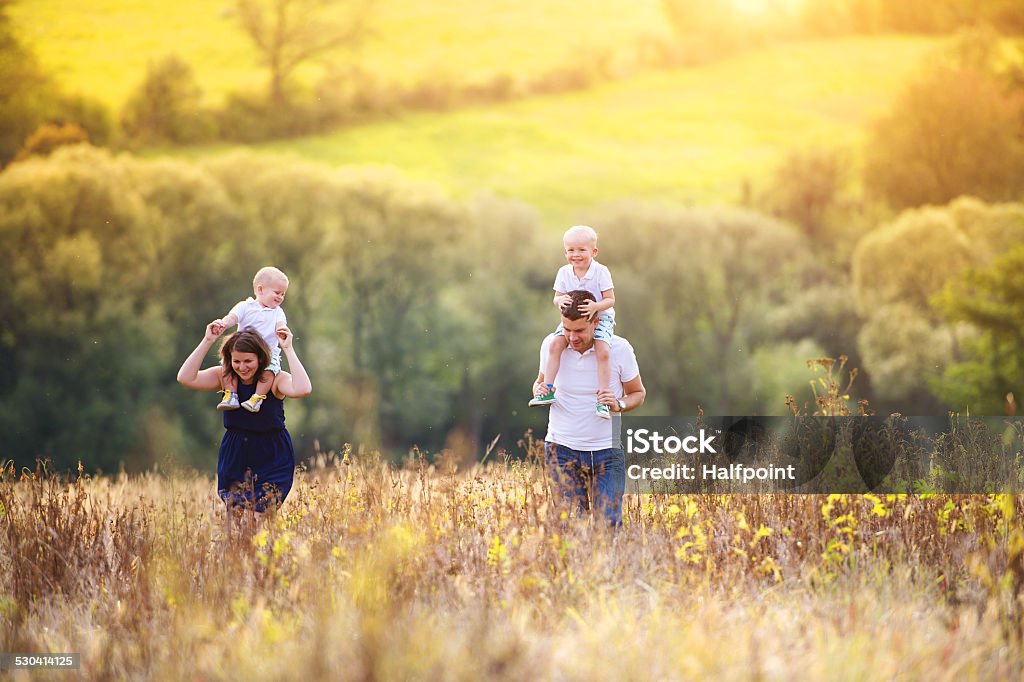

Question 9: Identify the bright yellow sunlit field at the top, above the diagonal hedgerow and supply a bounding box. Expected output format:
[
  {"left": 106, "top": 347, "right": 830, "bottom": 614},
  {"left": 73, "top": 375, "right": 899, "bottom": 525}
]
[{"left": 10, "top": 0, "right": 670, "bottom": 109}]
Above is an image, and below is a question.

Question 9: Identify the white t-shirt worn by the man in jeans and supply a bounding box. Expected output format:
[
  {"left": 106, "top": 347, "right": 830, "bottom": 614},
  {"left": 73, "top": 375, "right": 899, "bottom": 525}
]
[{"left": 540, "top": 334, "right": 640, "bottom": 450}]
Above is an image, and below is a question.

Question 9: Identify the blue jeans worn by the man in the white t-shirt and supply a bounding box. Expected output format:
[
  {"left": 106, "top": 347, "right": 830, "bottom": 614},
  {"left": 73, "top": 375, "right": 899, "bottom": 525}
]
[{"left": 544, "top": 442, "right": 626, "bottom": 526}]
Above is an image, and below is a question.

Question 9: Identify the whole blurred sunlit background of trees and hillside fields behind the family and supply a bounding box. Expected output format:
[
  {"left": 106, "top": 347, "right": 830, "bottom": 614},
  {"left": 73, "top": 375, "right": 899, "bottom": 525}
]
[{"left": 0, "top": 0, "right": 1024, "bottom": 471}]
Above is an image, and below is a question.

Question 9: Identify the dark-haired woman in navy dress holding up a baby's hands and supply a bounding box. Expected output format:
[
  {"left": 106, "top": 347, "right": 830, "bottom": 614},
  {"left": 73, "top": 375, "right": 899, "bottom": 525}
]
[{"left": 178, "top": 323, "right": 312, "bottom": 512}]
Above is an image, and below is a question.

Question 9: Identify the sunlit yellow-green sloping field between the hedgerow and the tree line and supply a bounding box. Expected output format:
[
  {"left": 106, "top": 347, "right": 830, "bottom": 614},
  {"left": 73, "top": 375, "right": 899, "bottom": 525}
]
[{"left": 173, "top": 38, "right": 935, "bottom": 226}]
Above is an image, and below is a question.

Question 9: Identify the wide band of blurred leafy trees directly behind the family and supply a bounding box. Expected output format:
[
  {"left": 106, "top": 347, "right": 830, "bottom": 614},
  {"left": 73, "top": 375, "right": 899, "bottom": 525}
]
[{"left": 6, "top": 145, "right": 1024, "bottom": 471}]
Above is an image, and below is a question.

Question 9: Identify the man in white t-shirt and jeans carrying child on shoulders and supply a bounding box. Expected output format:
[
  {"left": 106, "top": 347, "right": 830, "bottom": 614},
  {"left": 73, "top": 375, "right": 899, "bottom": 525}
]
[{"left": 534, "top": 291, "right": 647, "bottom": 525}]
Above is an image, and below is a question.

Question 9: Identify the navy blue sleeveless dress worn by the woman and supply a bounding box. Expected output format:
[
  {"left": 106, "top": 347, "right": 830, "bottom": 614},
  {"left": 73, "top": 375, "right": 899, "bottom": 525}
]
[{"left": 217, "top": 381, "right": 295, "bottom": 512}]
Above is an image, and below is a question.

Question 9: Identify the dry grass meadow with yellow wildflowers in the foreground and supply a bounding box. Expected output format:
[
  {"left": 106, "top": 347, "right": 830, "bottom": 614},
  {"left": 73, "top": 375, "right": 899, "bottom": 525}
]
[{"left": 0, "top": 446, "right": 1024, "bottom": 680}]
